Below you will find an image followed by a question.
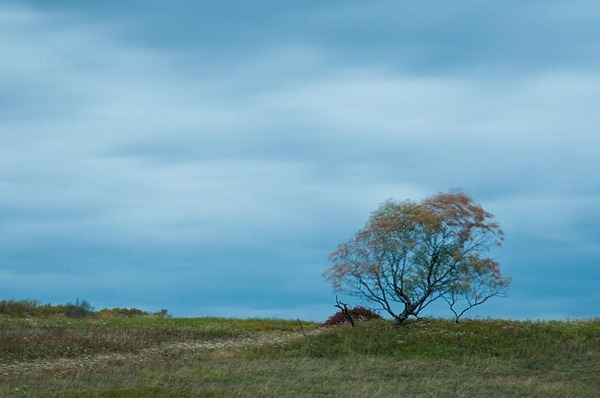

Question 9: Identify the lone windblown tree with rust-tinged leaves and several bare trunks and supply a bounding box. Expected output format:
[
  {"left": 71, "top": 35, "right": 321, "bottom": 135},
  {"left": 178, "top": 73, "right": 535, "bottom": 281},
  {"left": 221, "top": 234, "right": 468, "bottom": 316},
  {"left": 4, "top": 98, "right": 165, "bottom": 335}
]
[{"left": 324, "top": 191, "right": 510, "bottom": 323}]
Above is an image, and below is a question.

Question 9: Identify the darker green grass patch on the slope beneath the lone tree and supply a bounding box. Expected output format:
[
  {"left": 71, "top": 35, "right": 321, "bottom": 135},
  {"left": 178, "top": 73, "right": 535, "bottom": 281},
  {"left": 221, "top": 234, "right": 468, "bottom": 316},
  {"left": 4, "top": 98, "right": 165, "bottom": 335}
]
[{"left": 257, "top": 319, "right": 600, "bottom": 366}]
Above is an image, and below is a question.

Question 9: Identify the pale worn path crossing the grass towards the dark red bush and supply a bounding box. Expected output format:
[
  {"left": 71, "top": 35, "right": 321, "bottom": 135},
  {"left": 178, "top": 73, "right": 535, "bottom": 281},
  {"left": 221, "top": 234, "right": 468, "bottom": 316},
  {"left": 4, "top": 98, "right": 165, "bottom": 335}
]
[{"left": 0, "top": 331, "right": 318, "bottom": 378}]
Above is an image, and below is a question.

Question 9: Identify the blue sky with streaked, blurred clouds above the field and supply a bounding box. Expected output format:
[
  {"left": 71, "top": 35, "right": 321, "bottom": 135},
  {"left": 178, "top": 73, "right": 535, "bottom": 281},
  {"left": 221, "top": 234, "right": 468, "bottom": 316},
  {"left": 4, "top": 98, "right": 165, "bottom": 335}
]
[{"left": 0, "top": 0, "right": 600, "bottom": 320}]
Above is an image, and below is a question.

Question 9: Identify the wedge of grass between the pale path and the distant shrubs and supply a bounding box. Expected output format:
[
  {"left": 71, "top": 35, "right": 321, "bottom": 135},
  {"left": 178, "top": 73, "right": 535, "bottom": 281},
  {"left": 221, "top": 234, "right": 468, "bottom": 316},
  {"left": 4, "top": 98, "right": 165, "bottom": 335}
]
[{"left": 0, "top": 318, "right": 299, "bottom": 364}]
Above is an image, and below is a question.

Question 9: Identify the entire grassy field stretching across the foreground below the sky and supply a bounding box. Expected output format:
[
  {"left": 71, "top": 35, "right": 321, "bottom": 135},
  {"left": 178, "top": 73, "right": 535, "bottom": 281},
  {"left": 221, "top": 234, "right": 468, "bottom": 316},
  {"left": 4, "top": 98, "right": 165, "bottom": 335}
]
[{"left": 0, "top": 317, "right": 600, "bottom": 397}]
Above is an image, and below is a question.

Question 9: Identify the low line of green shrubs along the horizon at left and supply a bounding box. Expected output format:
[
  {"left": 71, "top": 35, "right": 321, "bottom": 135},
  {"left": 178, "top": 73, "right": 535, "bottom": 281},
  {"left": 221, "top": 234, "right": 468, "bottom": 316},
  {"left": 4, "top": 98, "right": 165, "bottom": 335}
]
[{"left": 0, "top": 298, "right": 172, "bottom": 319}]
